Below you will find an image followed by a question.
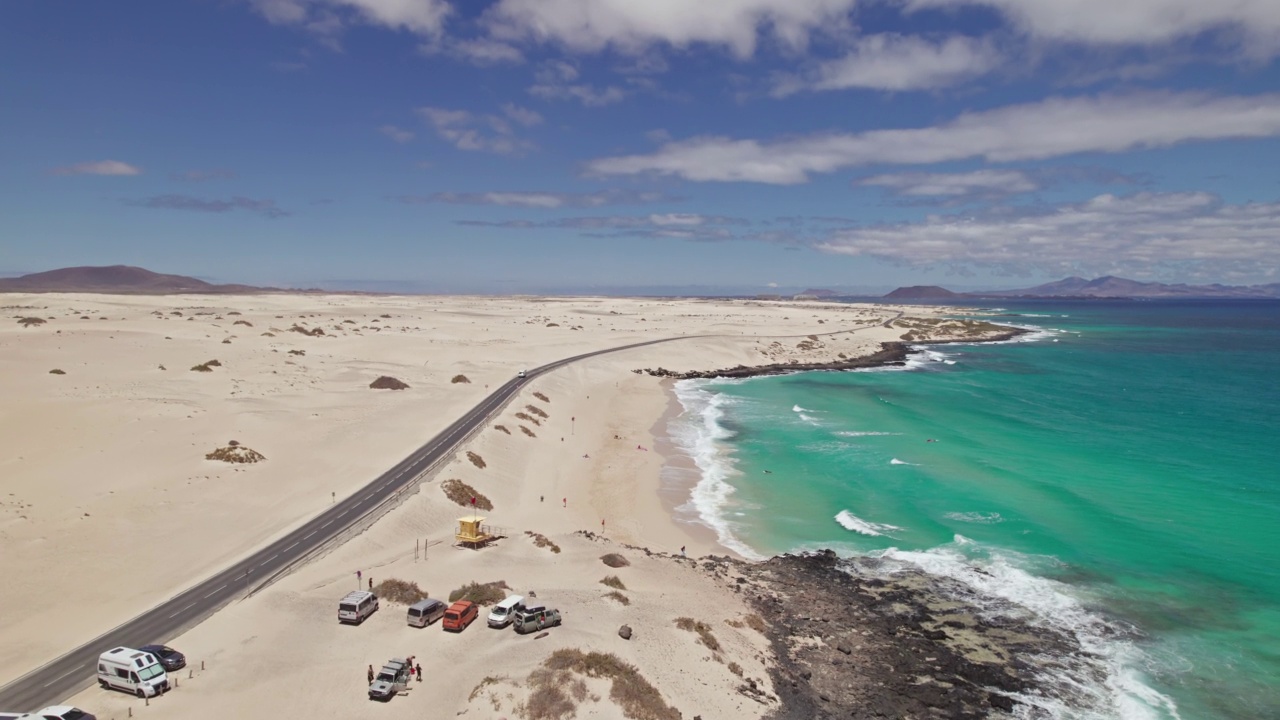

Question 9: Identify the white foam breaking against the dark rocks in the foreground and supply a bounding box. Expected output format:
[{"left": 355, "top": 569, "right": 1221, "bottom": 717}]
[{"left": 870, "top": 536, "right": 1181, "bottom": 720}]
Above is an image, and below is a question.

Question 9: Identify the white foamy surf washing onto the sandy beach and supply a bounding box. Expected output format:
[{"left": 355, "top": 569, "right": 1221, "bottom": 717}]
[{"left": 668, "top": 380, "right": 763, "bottom": 559}]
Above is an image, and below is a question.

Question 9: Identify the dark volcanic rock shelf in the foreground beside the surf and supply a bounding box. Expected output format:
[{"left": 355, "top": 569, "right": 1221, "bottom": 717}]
[{"left": 717, "top": 551, "right": 1101, "bottom": 720}]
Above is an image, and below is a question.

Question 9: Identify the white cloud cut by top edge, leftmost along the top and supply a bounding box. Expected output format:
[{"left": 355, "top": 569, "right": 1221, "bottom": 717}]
[{"left": 248, "top": 0, "right": 453, "bottom": 42}]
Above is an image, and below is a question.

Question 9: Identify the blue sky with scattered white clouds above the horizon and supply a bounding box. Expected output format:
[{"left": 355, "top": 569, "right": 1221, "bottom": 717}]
[{"left": 0, "top": 0, "right": 1280, "bottom": 292}]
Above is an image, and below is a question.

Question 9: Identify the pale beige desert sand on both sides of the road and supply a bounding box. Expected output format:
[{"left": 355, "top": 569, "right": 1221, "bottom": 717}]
[{"left": 0, "top": 295, "right": 1008, "bottom": 720}]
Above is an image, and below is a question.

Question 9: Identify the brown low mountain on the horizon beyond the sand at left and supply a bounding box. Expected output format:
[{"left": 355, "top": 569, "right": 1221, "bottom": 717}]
[{"left": 0, "top": 265, "right": 276, "bottom": 295}]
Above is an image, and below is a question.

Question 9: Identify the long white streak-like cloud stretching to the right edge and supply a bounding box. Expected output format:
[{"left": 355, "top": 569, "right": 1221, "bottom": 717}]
[{"left": 588, "top": 92, "right": 1280, "bottom": 184}]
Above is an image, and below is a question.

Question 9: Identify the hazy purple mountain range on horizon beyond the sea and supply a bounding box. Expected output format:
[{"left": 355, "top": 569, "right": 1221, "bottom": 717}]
[{"left": 884, "top": 275, "right": 1280, "bottom": 300}]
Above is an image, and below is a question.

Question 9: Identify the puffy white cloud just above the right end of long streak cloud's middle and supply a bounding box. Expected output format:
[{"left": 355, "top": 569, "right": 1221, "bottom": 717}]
[{"left": 773, "top": 33, "right": 1000, "bottom": 96}]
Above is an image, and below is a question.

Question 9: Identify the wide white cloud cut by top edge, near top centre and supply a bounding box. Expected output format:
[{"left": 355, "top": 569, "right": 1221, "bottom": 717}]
[{"left": 485, "top": 0, "right": 856, "bottom": 58}]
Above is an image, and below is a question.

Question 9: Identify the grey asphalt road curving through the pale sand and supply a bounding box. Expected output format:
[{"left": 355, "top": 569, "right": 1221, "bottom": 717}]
[{"left": 0, "top": 336, "right": 694, "bottom": 712}]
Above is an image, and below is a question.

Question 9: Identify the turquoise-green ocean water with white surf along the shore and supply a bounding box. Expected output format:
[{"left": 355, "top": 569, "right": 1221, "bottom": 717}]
[{"left": 669, "top": 301, "right": 1280, "bottom": 720}]
